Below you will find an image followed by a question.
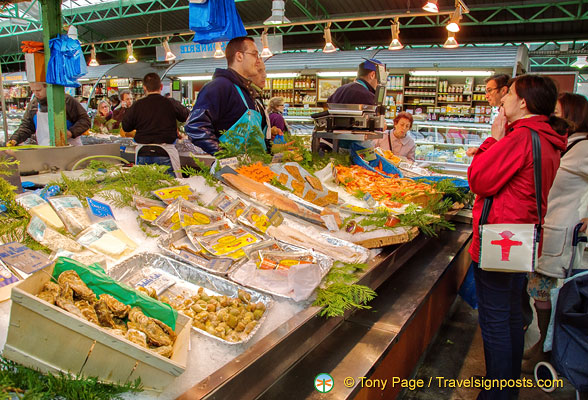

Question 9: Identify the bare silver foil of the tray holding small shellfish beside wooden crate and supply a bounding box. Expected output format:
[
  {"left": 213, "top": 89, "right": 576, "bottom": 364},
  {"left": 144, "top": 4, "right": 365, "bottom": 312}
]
[{"left": 108, "top": 253, "right": 273, "bottom": 344}]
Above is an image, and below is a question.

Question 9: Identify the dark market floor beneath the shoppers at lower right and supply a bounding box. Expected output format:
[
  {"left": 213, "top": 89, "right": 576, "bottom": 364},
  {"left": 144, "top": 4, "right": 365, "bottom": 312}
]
[{"left": 399, "top": 297, "right": 575, "bottom": 400}]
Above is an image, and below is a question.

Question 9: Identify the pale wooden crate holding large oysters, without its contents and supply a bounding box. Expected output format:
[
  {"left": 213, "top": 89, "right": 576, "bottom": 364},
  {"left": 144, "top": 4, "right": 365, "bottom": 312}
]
[{"left": 3, "top": 265, "right": 192, "bottom": 391}]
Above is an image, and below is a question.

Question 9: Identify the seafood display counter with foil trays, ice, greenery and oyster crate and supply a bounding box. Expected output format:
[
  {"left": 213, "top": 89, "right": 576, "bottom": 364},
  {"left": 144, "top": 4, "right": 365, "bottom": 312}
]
[{"left": 2, "top": 134, "right": 470, "bottom": 398}]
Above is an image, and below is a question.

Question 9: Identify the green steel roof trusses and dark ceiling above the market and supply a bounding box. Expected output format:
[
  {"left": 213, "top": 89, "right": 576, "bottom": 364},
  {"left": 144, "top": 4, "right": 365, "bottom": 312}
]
[{"left": 0, "top": 0, "right": 588, "bottom": 70}]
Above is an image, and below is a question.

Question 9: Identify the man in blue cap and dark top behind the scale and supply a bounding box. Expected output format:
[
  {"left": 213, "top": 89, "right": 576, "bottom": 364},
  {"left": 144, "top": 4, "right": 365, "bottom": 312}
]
[{"left": 327, "top": 58, "right": 382, "bottom": 105}]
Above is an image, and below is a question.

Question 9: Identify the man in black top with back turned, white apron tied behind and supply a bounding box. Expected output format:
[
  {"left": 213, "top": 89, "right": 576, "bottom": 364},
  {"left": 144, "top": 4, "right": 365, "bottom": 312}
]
[{"left": 122, "top": 72, "right": 188, "bottom": 177}]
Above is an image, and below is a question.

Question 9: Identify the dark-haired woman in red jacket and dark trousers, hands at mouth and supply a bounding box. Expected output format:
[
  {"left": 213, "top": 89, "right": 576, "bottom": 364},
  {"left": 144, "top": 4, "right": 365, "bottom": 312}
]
[{"left": 468, "top": 75, "right": 567, "bottom": 400}]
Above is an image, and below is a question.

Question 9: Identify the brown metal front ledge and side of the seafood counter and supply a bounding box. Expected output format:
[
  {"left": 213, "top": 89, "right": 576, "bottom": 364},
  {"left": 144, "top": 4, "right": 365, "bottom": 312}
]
[{"left": 179, "top": 223, "right": 472, "bottom": 400}]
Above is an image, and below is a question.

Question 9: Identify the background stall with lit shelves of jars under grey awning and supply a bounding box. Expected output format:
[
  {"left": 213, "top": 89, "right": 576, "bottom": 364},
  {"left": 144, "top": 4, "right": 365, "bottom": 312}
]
[{"left": 166, "top": 46, "right": 529, "bottom": 175}]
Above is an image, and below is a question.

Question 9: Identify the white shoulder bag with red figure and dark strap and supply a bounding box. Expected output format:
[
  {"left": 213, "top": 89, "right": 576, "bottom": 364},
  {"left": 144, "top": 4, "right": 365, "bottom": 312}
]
[{"left": 480, "top": 130, "right": 541, "bottom": 272}]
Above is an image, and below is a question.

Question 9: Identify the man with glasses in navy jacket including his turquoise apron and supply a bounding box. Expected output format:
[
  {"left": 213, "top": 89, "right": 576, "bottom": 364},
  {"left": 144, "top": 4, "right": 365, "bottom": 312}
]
[{"left": 184, "top": 36, "right": 267, "bottom": 154}]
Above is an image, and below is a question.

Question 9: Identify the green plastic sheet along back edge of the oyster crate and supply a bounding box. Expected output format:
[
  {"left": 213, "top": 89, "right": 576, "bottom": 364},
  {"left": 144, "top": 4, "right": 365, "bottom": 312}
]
[{"left": 53, "top": 257, "right": 178, "bottom": 331}]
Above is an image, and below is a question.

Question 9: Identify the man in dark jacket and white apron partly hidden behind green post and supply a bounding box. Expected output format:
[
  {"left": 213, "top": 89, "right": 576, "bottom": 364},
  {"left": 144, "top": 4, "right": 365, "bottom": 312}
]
[{"left": 6, "top": 82, "right": 91, "bottom": 146}]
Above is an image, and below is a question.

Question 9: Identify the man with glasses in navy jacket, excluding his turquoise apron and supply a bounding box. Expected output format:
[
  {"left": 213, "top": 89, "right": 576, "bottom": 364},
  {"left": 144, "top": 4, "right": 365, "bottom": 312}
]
[{"left": 184, "top": 36, "right": 263, "bottom": 154}]
